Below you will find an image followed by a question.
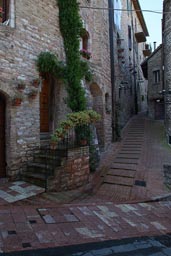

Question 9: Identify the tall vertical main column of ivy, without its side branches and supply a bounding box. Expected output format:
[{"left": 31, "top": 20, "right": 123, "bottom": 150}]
[{"left": 56, "top": 0, "right": 86, "bottom": 111}]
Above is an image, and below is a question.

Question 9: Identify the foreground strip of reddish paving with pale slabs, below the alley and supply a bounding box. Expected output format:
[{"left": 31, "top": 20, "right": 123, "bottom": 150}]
[{"left": 0, "top": 201, "right": 171, "bottom": 252}]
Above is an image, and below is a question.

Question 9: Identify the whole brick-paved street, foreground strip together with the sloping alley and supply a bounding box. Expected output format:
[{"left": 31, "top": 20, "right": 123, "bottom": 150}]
[{"left": 0, "top": 116, "right": 171, "bottom": 256}]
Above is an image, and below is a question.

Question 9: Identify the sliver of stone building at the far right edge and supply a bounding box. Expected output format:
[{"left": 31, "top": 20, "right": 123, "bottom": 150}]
[{"left": 163, "top": 0, "right": 171, "bottom": 144}]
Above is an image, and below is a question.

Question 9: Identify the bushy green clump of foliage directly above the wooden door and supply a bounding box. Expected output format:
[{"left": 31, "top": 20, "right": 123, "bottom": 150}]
[{"left": 36, "top": 52, "right": 66, "bottom": 79}]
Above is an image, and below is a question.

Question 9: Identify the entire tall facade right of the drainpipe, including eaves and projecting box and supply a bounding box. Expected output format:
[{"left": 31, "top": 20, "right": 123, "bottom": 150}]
[{"left": 113, "top": 0, "right": 149, "bottom": 130}]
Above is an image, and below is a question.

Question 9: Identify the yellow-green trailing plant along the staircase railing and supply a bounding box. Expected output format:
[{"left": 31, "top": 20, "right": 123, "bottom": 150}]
[{"left": 52, "top": 110, "right": 101, "bottom": 142}]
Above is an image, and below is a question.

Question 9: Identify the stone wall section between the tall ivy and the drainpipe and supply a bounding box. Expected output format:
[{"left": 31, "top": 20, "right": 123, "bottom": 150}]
[{"left": 79, "top": 0, "right": 112, "bottom": 148}]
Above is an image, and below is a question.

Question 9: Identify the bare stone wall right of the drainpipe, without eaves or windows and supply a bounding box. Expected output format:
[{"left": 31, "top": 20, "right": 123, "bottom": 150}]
[{"left": 114, "top": 0, "right": 147, "bottom": 129}]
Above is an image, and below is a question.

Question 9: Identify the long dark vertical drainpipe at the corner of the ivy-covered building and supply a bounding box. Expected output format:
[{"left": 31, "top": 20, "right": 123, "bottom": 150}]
[{"left": 108, "top": 0, "right": 116, "bottom": 142}]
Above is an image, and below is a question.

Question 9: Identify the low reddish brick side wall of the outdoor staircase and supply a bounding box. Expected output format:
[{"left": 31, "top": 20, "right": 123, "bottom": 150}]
[{"left": 47, "top": 147, "right": 90, "bottom": 192}]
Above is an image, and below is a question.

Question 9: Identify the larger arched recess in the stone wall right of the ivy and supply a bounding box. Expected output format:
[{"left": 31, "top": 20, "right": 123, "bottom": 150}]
[{"left": 90, "top": 83, "right": 104, "bottom": 148}]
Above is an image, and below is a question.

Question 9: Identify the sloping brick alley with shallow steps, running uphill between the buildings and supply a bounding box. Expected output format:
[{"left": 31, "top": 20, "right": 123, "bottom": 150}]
[{"left": 75, "top": 115, "right": 171, "bottom": 202}]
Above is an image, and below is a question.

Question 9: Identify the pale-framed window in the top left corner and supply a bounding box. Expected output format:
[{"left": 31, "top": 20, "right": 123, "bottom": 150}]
[{"left": 0, "top": 0, "right": 15, "bottom": 28}]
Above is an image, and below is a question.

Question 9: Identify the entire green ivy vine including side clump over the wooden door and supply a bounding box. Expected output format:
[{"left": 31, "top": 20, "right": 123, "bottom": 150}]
[{"left": 36, "top": 0, "right": 93, "bottom": 112}]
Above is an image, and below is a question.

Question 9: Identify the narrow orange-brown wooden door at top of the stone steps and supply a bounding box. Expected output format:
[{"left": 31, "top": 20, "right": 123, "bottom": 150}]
[{"left": 40, "top": 80, "right": 49, "bottom": 132}]
